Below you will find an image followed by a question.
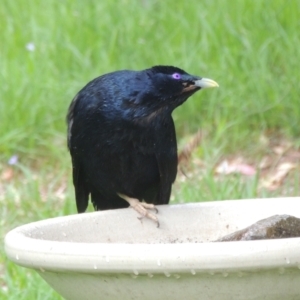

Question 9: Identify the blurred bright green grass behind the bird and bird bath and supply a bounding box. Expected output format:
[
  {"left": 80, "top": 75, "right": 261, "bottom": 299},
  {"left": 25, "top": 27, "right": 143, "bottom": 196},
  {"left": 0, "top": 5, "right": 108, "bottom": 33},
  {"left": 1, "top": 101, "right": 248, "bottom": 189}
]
[{"left": 0, "top": 0, "right": 300, "bottom": 300}]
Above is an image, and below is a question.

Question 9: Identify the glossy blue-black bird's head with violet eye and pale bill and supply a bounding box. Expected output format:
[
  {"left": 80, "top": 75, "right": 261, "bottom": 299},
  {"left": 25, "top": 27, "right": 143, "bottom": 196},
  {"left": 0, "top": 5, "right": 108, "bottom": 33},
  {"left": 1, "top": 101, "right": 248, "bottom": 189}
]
[{"left": 129, "top": 66, "right": 219, "bottom": 122}]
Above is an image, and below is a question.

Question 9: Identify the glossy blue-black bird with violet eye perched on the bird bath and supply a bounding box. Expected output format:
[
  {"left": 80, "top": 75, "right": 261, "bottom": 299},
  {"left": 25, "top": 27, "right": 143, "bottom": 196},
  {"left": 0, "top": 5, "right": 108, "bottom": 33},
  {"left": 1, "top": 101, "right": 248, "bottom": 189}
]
[{"left": 67, "top": 66, "right": 218, "bottom": 226}]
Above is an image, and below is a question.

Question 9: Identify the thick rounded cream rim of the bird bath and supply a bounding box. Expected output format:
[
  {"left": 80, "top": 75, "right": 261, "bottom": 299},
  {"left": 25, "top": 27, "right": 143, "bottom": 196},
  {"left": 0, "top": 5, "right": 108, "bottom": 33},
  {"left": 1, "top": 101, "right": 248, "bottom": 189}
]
[{"left": 5, "top": 198, "right": 300, "bottom": 274}]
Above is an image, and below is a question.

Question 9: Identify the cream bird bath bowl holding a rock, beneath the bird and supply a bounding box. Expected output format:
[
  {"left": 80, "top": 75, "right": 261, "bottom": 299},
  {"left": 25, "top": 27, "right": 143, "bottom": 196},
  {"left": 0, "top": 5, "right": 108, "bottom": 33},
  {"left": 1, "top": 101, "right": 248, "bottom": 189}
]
[{"left": 5, "top": 198, "right": 300, "bottom": 300}]
